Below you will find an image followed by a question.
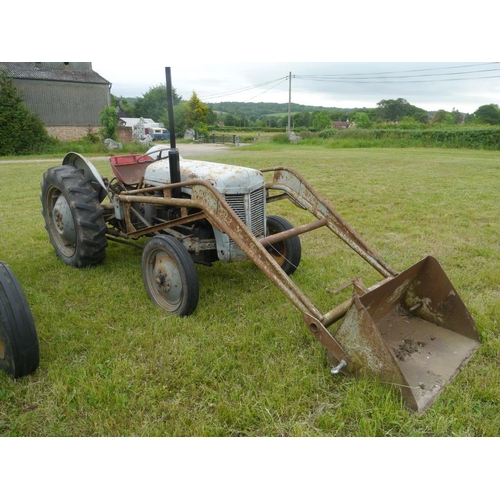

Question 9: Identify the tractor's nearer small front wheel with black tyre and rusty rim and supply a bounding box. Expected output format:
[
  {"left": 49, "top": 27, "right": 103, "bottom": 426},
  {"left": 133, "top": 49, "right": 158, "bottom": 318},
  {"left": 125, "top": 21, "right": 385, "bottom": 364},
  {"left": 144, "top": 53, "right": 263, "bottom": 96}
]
[{"left": 142, "top": 235, "right": 199, "bottom": 316}]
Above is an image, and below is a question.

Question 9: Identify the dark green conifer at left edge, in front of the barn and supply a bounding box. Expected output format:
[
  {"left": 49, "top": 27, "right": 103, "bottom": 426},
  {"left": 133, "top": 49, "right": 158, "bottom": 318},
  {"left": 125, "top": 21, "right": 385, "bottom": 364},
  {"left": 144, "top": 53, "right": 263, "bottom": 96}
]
[{"left": 0, "top": 68, "right": 53, "bottom": 155}]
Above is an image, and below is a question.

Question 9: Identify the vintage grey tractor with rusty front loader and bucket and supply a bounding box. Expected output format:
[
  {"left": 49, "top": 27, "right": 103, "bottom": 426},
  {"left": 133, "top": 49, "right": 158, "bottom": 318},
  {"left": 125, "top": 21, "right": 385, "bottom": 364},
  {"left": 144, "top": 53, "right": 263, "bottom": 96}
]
[{"left": 41, "top": 68, "right": 479, "bottom": 412}]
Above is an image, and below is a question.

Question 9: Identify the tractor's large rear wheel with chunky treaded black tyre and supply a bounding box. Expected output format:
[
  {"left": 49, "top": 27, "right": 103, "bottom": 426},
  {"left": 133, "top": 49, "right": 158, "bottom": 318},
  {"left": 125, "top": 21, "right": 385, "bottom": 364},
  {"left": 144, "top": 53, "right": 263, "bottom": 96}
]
[{"left": 41, "top": 165, "right": 108, "bottom": 267}]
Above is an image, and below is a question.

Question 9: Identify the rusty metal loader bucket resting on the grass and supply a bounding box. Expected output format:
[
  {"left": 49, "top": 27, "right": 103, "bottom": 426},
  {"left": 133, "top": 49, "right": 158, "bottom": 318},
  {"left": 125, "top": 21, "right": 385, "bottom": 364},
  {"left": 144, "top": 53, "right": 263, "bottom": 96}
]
[{"left": 335, "top": 257, "right": 479, "bottom": 413}]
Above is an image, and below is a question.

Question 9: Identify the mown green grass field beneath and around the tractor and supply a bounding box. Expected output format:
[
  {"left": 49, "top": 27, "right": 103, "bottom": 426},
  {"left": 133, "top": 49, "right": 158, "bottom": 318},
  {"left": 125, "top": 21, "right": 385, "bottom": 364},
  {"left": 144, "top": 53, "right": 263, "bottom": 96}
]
[{"left": 0, "top": 144, "right": 500, "bottom": 436}]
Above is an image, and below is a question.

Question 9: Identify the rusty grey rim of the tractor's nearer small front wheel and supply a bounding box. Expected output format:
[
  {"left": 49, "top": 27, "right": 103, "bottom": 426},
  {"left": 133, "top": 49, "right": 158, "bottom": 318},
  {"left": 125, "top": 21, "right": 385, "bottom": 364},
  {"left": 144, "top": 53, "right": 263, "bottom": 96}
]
[{"left": 147, "top": 250, "right": 183, "bottom": 311}]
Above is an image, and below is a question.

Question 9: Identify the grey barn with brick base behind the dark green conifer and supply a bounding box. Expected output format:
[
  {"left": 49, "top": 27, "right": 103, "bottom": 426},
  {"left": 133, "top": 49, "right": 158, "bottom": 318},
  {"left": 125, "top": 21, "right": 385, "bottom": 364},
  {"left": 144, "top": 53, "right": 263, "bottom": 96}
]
[{"left": 0, "top": 62, "right": 111, "bottom": 140}]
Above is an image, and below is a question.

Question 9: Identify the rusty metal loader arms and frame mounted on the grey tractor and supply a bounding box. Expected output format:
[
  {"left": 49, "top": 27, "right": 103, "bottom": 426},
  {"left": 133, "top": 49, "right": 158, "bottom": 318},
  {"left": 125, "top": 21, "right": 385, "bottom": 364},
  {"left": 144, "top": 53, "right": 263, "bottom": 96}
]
[{"left": 110, "top": 167, "right": 406, "bottom": 372}]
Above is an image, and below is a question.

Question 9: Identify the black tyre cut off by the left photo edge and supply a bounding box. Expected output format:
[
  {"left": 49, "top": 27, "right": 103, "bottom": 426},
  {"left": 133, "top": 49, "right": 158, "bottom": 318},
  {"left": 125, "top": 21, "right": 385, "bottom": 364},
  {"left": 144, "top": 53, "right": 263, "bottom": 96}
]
[{"left": 0, "top": 262, "right": 40, "bottom": 378}]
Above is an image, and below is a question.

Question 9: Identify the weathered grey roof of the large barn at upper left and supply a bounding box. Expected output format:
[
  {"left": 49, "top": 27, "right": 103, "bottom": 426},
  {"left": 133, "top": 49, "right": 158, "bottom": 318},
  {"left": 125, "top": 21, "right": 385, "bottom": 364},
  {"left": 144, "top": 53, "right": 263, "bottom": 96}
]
[{"left": 0, "top": 62, "right": 111, "bottom": 85}]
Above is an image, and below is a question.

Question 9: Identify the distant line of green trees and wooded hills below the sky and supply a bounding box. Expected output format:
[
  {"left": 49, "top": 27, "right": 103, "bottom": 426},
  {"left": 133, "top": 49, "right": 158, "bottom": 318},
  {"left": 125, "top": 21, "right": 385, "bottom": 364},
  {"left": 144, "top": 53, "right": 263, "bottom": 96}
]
[{"left": 120, "top": 85, "right": 500, "bottom": 132}]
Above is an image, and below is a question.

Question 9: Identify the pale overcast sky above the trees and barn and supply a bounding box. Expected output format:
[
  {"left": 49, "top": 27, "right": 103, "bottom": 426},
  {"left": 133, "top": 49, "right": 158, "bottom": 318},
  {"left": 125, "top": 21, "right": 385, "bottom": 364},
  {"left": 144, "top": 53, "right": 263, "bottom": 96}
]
[{"left": 92, "top": 58, "right": 500, "bottom": 113}]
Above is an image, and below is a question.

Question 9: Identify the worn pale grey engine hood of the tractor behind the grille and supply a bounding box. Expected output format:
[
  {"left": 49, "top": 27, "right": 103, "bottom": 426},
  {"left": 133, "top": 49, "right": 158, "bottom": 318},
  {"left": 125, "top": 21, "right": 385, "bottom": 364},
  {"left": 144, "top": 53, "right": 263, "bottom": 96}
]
[{"left": 144, "top": 159, "right": 264, "bottom": 194}]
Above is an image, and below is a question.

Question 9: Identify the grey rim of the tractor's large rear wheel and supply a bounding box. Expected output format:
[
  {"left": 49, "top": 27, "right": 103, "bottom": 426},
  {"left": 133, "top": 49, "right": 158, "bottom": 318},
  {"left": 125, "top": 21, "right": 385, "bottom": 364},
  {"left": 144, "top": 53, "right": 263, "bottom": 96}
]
[{"left": 47, "top": 188, "right": 76, "bottom": 257}]
